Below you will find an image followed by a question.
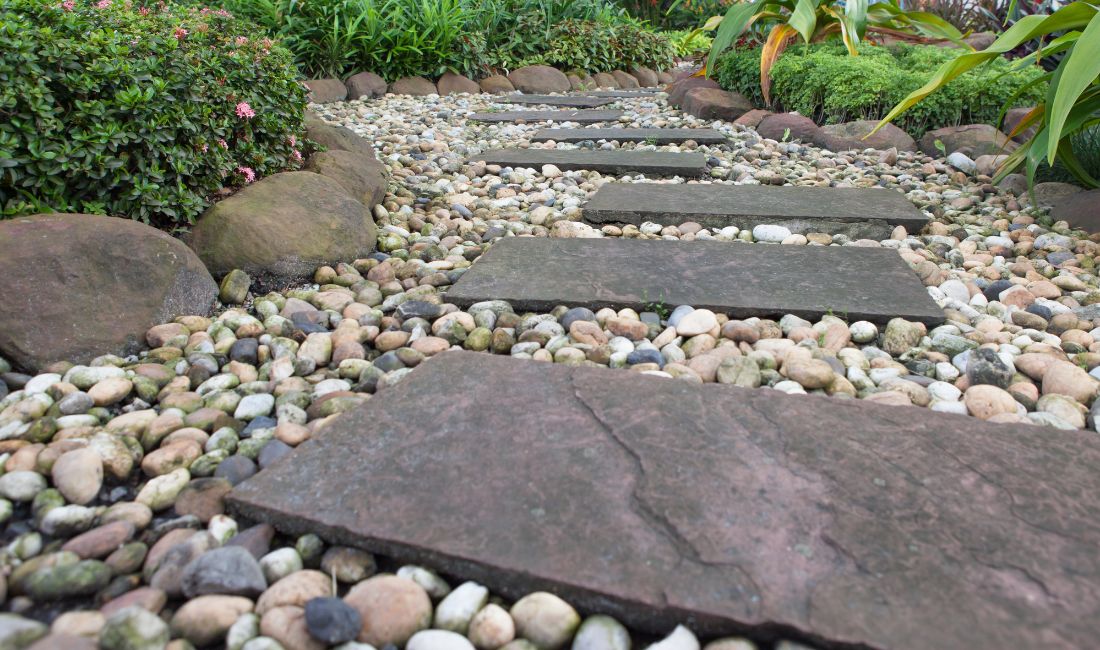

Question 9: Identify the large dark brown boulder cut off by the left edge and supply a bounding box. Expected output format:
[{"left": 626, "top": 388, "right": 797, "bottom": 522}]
[{"left": 0, "top": 214, "right": 218, "bottom": 372}]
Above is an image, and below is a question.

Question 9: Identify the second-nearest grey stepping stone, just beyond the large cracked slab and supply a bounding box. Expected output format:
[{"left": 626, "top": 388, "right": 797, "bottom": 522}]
[{"left": 447, "top": 238, "right": 944, "bottom": 324}]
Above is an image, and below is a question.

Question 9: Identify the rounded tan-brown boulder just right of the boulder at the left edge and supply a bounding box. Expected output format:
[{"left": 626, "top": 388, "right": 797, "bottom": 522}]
[{"left": 190, "top": 172, "right": 377, "bottom": 288}]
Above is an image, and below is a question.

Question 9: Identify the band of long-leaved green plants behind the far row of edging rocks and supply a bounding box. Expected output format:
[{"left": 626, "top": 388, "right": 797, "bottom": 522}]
[{"left": 201, "top": 0, "right": 673, "bottom": 81}]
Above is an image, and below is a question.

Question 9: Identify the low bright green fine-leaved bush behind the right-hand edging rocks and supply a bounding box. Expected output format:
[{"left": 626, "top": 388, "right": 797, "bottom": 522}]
[{"left": 715, "top": 43, "right": 1045, "bottom": 137}]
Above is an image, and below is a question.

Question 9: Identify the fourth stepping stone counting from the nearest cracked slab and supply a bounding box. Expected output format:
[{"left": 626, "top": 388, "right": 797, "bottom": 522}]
[{"left": 468, "top": 148, "right": 706, "bottom": 177}]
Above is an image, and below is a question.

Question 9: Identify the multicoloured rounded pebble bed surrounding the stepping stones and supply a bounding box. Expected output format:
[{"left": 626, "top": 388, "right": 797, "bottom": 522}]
[{"left": 0, "top": 87, "right": 1100, "bottom": 650}]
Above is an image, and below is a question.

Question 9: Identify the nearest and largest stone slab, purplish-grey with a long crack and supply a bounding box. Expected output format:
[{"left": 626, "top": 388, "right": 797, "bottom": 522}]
[{"left": 229, "top": 352, "right": 1100, "bottom": 650}]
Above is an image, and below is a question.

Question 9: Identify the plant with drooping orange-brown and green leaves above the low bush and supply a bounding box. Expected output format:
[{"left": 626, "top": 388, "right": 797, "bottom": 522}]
[{"left": 704, "top": 0, "right": 966, "bottom": 99}]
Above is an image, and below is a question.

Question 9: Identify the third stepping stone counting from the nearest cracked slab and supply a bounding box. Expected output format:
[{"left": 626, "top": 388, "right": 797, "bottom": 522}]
[{"left": 584, "top": 183, "right": 928, "bottom": 240}]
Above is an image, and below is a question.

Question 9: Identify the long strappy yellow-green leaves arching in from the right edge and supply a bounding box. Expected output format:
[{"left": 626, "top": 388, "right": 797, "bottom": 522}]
[{"left": 877, "top": 1, "right": 1100, "bottom": 187}]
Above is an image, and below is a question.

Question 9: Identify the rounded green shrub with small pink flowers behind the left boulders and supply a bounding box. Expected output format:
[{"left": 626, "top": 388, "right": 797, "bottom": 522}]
[{"left": 0, "top": 0, "right": 306, "bottom": 228}]
